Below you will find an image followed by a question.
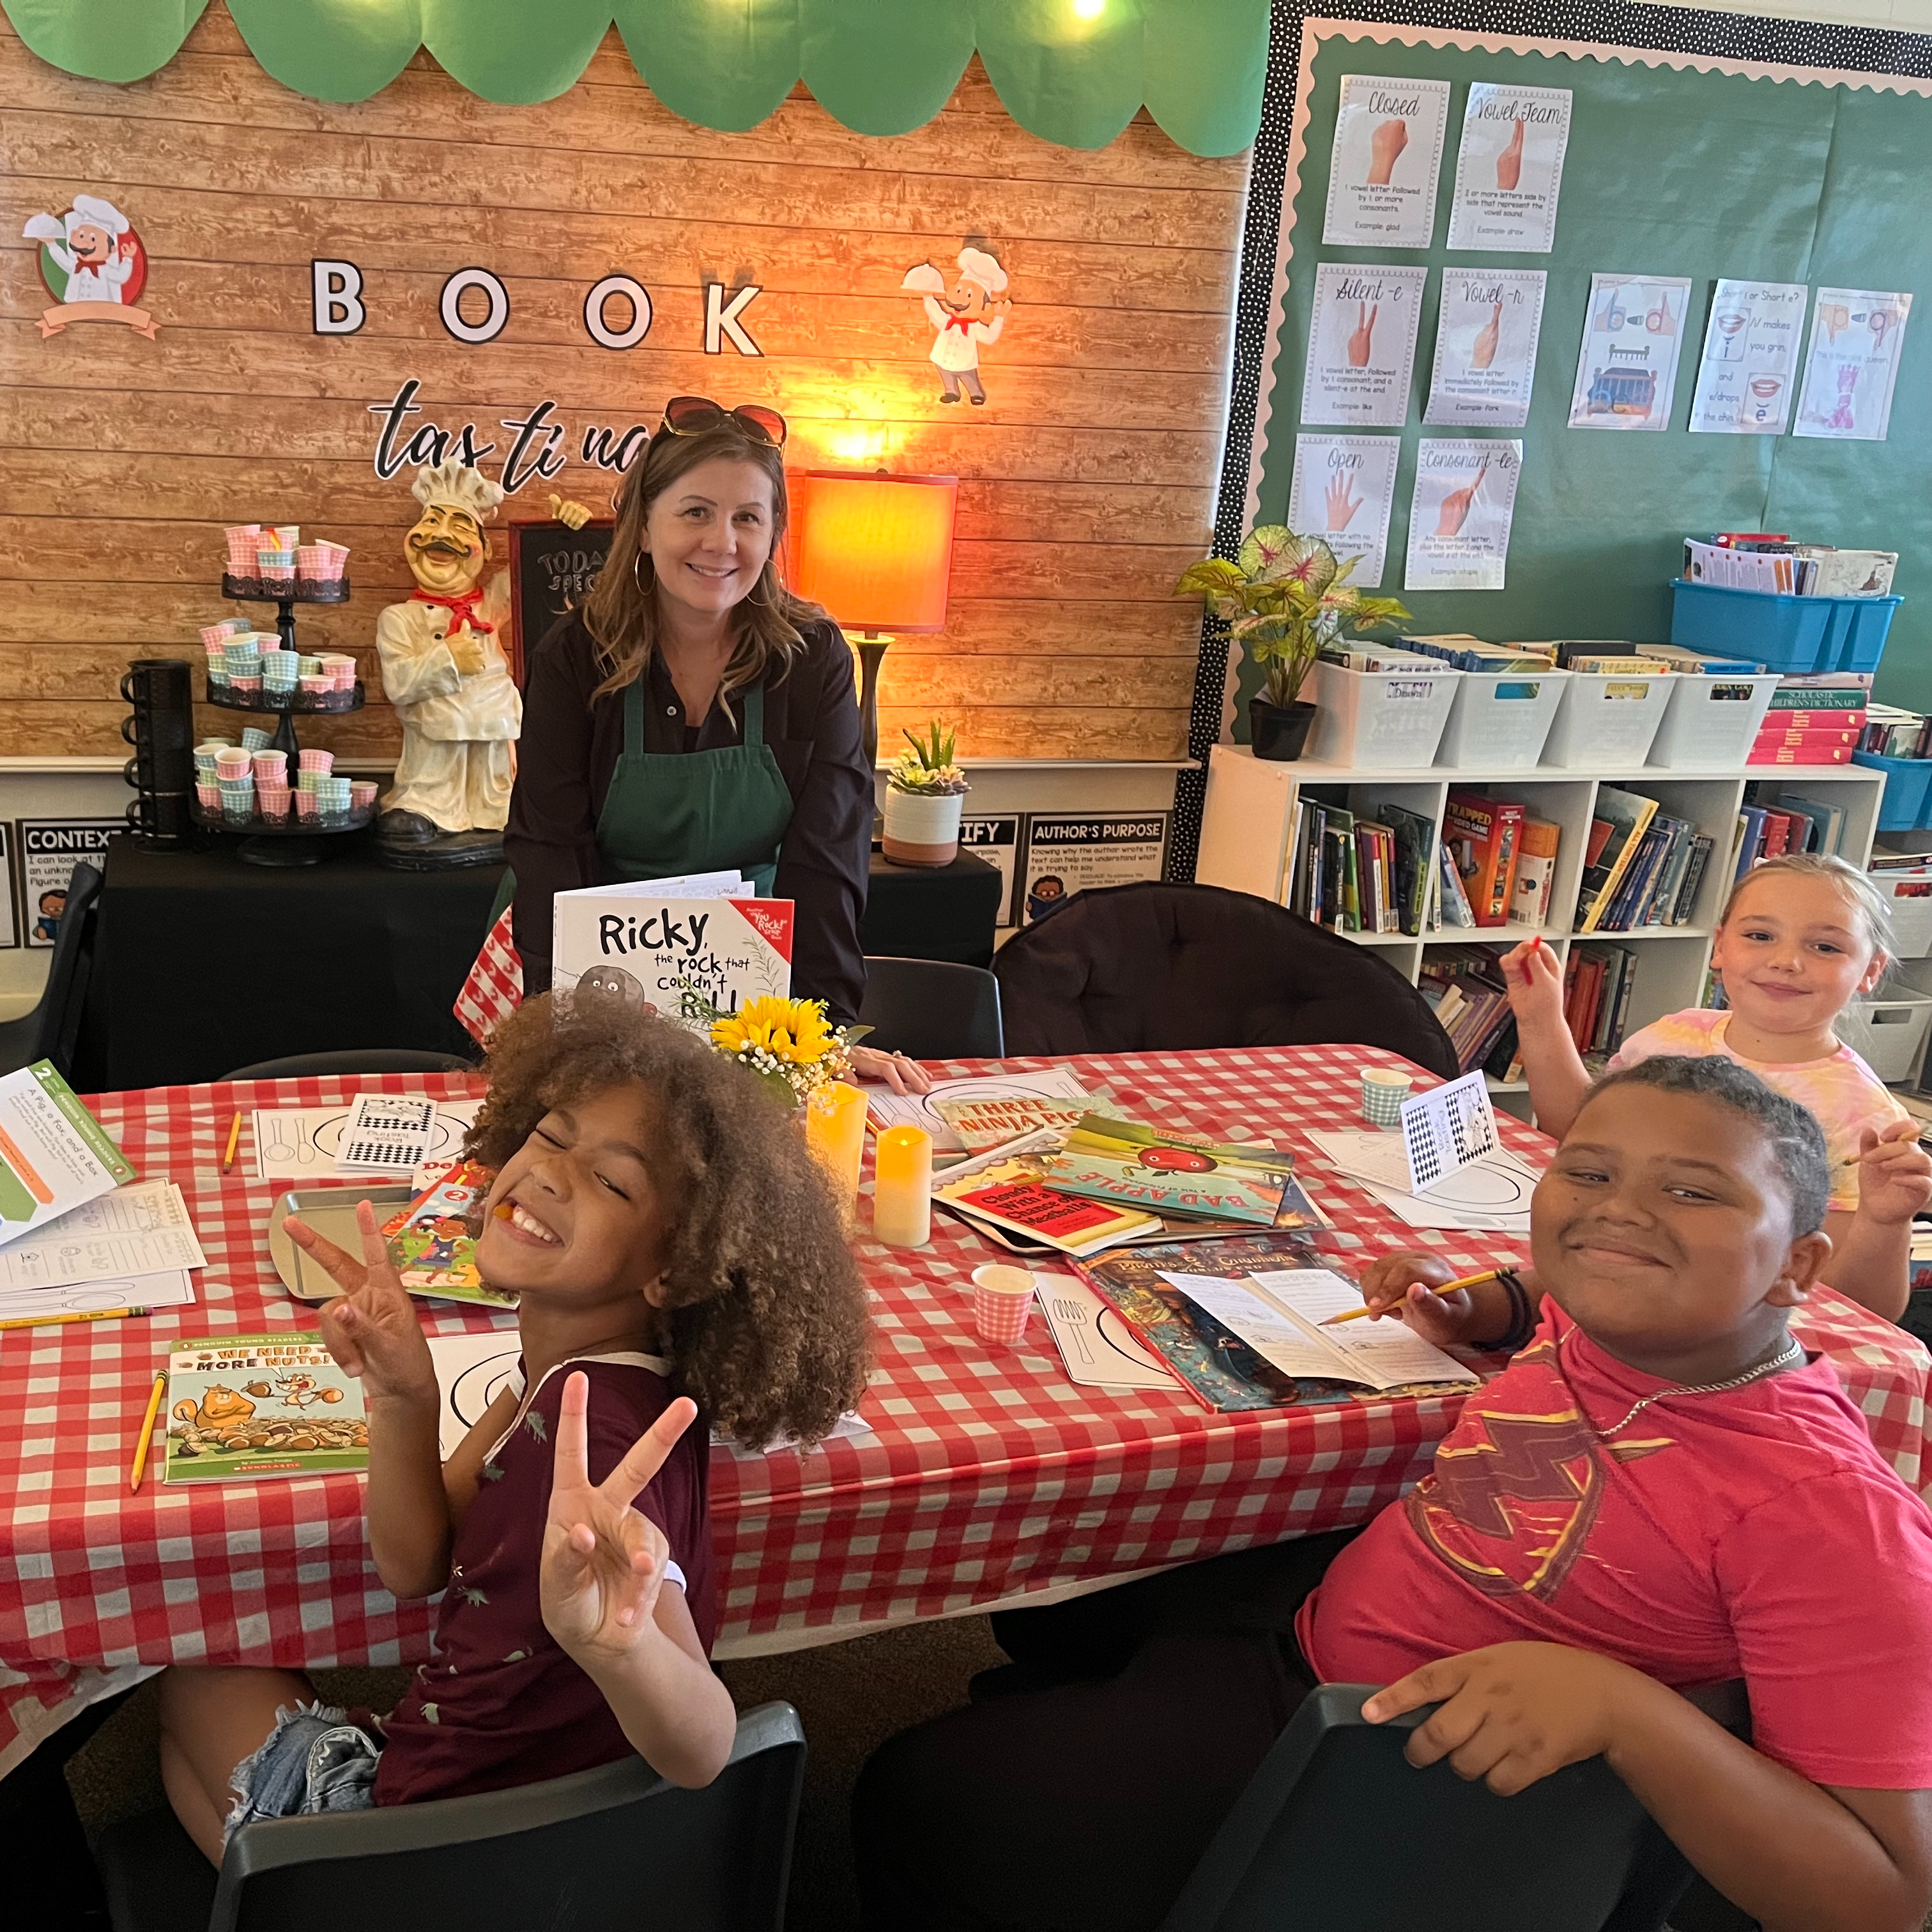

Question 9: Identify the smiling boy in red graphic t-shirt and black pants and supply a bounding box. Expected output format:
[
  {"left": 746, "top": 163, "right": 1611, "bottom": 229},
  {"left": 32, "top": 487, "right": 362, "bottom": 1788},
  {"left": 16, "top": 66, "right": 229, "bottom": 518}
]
[{"left": 854, "top": 1057, "right": 1932, "bottom": 1932}]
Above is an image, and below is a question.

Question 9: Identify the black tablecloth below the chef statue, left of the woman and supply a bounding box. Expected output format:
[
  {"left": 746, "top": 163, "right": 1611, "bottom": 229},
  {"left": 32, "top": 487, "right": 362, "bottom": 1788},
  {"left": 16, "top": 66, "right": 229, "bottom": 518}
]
[{"left": 96, "top": 838, "right": 502, "bottom": 1090}]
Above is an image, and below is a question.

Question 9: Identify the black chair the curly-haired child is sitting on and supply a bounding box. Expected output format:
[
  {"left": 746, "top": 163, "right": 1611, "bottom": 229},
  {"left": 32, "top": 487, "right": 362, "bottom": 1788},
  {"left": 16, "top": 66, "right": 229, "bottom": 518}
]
[{"left": 95, "top": 1704, "right": 806, "bottom": 1932}]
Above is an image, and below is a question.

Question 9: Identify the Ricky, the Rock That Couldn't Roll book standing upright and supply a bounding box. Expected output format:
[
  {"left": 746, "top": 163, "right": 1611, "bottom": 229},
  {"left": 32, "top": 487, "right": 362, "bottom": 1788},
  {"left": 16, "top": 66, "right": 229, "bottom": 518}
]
[{"left": 551, "top": 871, "right": 792, "bottom": 1034}]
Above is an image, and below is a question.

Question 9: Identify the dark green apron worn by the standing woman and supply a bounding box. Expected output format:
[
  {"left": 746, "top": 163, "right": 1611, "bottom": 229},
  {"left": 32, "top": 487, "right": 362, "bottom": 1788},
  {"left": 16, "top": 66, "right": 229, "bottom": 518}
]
[{"left": 506, "top": 672, "right": 792, "bottom": 921}]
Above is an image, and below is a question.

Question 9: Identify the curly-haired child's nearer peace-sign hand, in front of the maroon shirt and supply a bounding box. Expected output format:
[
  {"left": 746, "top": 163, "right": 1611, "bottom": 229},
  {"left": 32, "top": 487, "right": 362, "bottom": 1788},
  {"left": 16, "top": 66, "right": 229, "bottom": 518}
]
[{"left": 537, "top": 1370, "right": 698, "bottom": 1669}]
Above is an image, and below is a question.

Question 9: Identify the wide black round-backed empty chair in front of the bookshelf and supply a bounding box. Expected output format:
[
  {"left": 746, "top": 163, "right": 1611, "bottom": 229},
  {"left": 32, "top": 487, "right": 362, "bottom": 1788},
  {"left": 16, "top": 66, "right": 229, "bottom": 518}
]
[{"left": 993, "top": 885, "right": 1459, "bottom": 1080}]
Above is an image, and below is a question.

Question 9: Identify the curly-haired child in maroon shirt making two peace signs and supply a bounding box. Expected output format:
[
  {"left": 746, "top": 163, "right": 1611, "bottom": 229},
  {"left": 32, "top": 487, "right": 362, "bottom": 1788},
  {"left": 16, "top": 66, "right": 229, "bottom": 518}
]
[{"left": 160, "top": 997, "right": 868, "bottom": 1862}]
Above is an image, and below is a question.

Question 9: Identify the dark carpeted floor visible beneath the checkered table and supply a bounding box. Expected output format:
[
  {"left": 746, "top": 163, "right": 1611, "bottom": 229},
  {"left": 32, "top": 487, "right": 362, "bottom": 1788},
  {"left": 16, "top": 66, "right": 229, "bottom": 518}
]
[{"left": 68, "top": 1617, "right": 1004, "bottom": 1932}]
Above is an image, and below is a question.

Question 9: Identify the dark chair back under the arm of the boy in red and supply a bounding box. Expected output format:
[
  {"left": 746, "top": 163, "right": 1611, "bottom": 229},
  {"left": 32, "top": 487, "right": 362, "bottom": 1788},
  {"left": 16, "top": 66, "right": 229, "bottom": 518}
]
[{"left": 1159, "top": 1684, "right": 1690, "bottom": 1932}]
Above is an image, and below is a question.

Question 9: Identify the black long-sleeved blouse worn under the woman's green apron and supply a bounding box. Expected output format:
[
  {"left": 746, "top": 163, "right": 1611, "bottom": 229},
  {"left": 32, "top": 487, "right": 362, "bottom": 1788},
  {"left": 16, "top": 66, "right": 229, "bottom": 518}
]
[{"left": 502, "top": 613, "right": 873, "bottom": 1024}]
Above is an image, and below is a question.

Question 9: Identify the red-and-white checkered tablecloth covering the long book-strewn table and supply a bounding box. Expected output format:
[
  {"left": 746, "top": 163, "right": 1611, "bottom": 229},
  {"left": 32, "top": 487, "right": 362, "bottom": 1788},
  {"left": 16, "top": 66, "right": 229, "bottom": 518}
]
[{"left": 0, "top": 1047, "right": 1932, "bottom": 1770}]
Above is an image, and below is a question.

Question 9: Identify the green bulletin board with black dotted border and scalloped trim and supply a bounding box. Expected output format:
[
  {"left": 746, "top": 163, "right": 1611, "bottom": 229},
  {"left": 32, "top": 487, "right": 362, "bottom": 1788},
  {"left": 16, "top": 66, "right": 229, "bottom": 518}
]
[{"left": 1196, "top": 4, "right": 1932, "bottom": 749}]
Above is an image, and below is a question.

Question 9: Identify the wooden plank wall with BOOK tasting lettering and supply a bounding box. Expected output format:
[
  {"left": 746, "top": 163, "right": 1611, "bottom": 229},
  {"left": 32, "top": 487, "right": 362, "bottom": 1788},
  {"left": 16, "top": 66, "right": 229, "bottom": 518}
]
[{"left": 0, "top": 4, "right": 1244, "bottom": 757}]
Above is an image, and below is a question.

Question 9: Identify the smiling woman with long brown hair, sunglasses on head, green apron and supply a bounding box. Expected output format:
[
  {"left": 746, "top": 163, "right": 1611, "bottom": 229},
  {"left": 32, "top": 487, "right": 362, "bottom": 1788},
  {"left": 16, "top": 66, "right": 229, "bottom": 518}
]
[{"left": 504, "top": 396, "right": 925, "bottom": 1090}]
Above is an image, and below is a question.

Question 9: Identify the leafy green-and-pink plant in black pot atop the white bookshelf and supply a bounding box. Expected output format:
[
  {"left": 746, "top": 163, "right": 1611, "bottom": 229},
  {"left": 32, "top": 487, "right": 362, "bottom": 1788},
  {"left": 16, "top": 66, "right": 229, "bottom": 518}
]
[{"left": 1175, "top": 524, "right": 1408, "bottom": 759}]
